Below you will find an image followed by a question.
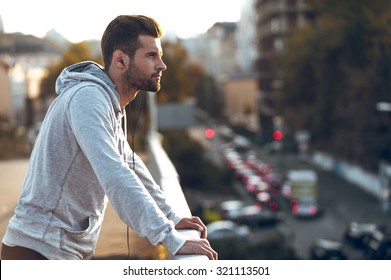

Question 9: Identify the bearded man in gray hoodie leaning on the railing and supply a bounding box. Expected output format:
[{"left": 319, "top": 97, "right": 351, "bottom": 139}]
[{"left": 2, "top": 16, "right": 217, "bottom": 259}]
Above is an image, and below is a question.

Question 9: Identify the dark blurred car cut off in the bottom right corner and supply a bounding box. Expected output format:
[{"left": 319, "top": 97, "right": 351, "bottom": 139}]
[{"left": 365, "top": 229, "right": 391, "bottom": 260}]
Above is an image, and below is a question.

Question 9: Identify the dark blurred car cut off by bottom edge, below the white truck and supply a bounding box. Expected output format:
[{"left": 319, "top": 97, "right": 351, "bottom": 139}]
[{"left": 309, "top": 238, "right": 348, "bottom": 260}]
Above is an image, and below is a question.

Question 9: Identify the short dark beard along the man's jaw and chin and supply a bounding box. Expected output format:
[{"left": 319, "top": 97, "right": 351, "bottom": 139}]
[{"left": 124, "top": 63, "right": 161, "bottom": 92}]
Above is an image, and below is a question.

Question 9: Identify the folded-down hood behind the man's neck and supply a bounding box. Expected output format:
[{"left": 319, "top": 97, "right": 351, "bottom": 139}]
[{"left": 56, "top": 61, "right": 121, "bottom": 113}]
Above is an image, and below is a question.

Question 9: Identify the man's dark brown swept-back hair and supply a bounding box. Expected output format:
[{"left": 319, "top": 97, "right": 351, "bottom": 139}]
[{"left": 101, "top": 15, "right": 162, "bottom": 70}]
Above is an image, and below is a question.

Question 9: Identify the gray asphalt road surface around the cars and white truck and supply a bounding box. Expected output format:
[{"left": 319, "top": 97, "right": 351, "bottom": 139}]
[{"left": 192, "top": 127, "right": 391, "bottom": 259}]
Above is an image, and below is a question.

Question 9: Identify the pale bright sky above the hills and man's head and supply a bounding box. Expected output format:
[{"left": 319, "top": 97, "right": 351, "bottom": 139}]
[{"left": 0, "top": 0, "right": 246, "bottom": 43}]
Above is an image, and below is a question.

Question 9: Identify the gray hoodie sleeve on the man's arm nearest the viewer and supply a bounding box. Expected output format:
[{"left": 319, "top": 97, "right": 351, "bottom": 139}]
[{"left": 68, "top": 85, "right": 185, "bottom": 254}]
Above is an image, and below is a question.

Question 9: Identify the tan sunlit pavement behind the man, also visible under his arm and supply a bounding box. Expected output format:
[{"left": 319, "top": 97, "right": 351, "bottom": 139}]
[{"left": 0, "top": 159, "right": 164, "bottom": 259}]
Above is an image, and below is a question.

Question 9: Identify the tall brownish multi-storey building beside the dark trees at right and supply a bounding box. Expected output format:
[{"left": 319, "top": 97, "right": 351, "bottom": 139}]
[{"left": 255, "top": 0, "right": 315, "bottom": 142}]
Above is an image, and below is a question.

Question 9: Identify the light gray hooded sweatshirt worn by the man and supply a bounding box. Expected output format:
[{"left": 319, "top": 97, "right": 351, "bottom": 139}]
[{"left": 3, "top": 62, "right": 185, "bottom": 259}]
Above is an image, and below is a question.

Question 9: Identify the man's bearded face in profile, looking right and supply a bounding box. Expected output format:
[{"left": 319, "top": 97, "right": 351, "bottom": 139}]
[{"left": 126, "top": 35, "right": 167, "bottom": 92}]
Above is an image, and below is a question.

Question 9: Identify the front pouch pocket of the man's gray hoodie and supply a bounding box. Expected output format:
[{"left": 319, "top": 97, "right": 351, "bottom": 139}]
[{"left": 60, "top": 216, "right": 101, "bottom": 259}]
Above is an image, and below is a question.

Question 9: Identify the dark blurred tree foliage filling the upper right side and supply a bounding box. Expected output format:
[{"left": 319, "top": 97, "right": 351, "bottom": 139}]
[{"left": 279, "top": 0, "right": 391, "bottom": 170}]
